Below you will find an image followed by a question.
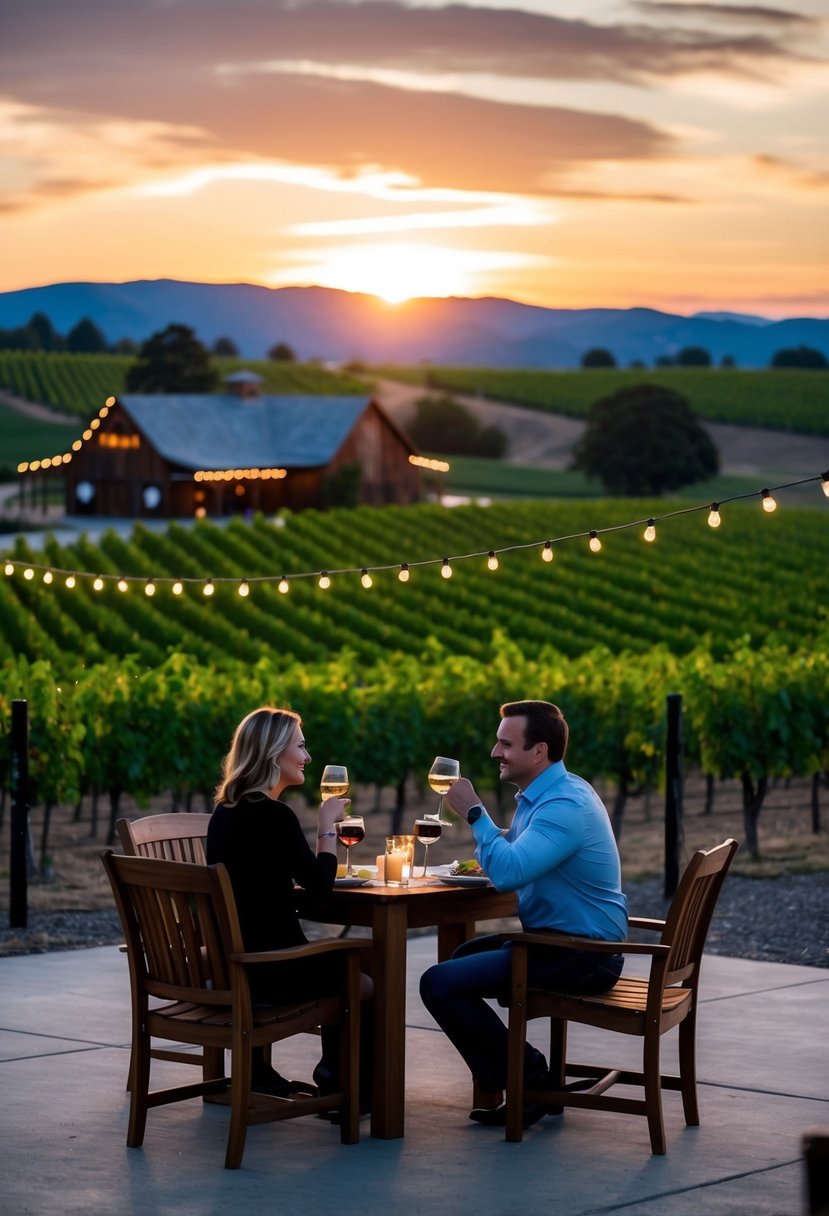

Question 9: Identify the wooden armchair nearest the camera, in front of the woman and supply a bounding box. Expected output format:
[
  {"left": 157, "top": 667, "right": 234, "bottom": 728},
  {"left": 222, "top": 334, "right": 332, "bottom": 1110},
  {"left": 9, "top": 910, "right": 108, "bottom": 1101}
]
[{"left": 102, "top": 850, "right": 367, "bottom": 1170}]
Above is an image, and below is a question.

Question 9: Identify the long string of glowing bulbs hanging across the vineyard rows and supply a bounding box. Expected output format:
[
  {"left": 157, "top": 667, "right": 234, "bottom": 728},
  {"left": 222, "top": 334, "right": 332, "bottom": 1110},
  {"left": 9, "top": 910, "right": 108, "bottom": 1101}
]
[{"left": 2, "top": 469, "right": 829, "bottom": 597}]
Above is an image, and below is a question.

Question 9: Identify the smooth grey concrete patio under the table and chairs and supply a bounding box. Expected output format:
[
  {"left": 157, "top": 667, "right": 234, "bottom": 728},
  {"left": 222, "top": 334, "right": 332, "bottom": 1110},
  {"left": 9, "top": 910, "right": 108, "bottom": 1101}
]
[{"left": 0, "top": 936, "right": 829, "bottom": 1216}]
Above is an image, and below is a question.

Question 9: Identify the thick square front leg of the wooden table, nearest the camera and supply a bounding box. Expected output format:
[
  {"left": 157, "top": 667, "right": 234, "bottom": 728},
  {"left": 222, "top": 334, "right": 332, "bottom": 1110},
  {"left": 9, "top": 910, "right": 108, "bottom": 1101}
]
[{"left": 371, "top": 900, "right": 407, "bottom": 1139}]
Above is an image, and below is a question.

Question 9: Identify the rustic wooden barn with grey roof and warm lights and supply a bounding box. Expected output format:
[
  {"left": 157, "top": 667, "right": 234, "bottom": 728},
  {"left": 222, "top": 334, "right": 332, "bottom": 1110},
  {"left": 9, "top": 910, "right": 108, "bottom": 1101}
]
[{"left": 53, "top": 372, "right": 421, "bottom": 518}]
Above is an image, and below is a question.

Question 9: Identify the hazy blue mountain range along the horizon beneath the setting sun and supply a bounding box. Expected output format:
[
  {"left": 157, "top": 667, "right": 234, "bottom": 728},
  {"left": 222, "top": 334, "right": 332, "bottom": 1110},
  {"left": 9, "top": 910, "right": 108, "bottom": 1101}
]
[{"left": 0, "top": 278, "right": 829, "bottom": 367}]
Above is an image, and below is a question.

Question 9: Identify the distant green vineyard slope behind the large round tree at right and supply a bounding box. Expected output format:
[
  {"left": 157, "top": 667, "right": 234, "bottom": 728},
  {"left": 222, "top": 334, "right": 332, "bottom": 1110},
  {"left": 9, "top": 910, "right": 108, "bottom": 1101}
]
[{"left": 372, "top": 367, "right": 829, "bottom": 435}]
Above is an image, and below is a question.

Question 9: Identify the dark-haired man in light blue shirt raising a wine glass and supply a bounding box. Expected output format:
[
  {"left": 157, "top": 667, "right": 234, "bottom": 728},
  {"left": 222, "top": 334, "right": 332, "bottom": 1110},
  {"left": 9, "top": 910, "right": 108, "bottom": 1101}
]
[{"left": 421, "top": 700, "right": 627, "bottom": 1127}]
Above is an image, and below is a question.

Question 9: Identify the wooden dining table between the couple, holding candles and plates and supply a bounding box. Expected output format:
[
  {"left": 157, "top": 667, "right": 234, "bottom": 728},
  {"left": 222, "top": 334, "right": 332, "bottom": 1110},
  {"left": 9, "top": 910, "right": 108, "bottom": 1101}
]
[{"left": 299, "top": 884, "right": 517, "bottom": 1139}]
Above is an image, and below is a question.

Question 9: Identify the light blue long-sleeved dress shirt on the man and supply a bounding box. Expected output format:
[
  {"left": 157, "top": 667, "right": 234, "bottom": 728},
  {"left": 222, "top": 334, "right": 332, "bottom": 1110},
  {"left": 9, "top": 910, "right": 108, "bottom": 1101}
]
[{"left": 472, "top": 760, "right": 627, "bottom": 941}]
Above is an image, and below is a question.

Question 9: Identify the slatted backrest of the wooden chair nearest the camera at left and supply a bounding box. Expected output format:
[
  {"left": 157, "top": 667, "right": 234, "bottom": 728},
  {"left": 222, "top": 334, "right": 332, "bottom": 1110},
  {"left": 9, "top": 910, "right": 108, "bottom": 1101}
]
[{"left": 101, "top": 851, "right": 243, "bottom": 1006}]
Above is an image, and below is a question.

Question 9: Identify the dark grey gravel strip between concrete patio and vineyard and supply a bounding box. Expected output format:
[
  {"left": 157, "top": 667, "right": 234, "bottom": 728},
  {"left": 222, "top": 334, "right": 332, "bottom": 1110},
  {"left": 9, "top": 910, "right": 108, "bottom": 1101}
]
[{"left": 0, "top": 872, "right": 829, "bottom": 967}]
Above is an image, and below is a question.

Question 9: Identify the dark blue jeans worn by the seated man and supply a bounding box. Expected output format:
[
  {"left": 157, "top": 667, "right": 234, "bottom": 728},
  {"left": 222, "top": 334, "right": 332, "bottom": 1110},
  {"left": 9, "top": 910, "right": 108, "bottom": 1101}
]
[{"left": 421, "top": 934, "right": 625, "bottom": 1091}]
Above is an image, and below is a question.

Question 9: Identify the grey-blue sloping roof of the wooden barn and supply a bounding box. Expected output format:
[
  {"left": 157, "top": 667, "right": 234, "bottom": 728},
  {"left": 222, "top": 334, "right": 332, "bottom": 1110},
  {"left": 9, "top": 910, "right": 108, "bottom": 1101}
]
[{"left": 118, "top": 394, "right": 372, "bottom": 469}]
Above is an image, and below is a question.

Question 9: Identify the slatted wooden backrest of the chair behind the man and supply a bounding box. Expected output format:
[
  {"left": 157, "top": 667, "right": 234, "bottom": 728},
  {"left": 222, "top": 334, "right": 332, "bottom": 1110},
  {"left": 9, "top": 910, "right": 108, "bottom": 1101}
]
[{"left": 661, "top": 839, "right": 738, "bottom": 984}]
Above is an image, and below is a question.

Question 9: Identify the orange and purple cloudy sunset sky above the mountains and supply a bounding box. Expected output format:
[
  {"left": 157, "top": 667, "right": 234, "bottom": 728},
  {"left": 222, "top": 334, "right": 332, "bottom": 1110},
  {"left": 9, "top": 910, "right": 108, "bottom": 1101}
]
[{"left": 0, "top": 0, "right": 829, "bottom": 317}]
